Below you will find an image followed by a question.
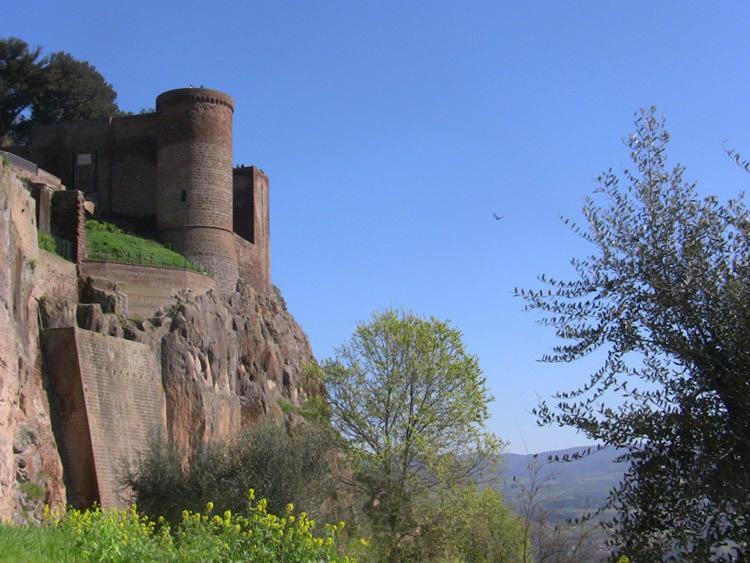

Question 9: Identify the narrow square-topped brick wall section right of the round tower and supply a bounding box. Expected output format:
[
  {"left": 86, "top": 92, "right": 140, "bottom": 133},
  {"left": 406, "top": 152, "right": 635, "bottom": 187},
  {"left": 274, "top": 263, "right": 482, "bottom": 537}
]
[{"left": 233, "top": 166, "right": 271, "bottom": 292}]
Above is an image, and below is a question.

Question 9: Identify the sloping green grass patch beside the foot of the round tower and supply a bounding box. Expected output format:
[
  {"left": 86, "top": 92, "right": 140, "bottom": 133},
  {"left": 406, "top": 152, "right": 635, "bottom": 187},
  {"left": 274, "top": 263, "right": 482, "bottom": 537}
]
[{"left": 86, "top": 219, "right": 203, "bottom": 272}]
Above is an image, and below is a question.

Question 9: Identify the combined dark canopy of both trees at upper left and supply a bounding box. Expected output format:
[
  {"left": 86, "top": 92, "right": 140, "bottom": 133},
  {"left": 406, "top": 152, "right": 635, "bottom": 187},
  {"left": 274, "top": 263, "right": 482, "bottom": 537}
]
[{"left": 0, "top": 37, "right": 119, "bottom": 143}]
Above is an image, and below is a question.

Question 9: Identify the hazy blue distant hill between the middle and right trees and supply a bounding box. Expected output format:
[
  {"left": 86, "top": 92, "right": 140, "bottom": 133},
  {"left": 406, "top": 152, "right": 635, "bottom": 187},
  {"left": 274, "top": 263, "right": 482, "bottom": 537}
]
[{"left": 494, "top": 447, "right": 625, "bottom": 521}]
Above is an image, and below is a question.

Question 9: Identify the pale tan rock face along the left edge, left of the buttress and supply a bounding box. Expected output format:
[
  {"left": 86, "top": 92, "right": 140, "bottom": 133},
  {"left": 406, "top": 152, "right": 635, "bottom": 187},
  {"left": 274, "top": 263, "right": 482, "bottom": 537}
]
[{"left": 0, "top": 163, "right": 66, "bottom": 523}]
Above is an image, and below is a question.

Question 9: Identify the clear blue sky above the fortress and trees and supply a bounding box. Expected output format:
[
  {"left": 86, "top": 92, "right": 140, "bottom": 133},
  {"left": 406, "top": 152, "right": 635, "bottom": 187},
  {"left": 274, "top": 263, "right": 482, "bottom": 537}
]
[{"left": 0, "top": 0, "right": 750, "bottom": 453}]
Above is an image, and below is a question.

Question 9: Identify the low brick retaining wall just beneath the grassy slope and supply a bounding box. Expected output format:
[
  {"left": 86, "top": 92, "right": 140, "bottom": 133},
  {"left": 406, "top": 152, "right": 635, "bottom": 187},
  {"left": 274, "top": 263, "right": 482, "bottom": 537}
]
[{"left": 81, "top": 261, "right": 216, "bottom": 319}]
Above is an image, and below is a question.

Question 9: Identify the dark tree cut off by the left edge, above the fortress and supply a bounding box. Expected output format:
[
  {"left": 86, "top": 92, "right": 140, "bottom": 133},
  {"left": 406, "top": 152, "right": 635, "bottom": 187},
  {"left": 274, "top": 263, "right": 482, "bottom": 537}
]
[{"left": 0, "top": 37, "right": 43, "bottom": 141}]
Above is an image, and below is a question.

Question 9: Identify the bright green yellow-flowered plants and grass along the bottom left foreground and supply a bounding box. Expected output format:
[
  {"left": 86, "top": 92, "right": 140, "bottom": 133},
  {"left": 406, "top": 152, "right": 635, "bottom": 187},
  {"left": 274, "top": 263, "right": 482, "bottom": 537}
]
[{"left": 16, "top": 490, "right": 350, "bottom": 562}]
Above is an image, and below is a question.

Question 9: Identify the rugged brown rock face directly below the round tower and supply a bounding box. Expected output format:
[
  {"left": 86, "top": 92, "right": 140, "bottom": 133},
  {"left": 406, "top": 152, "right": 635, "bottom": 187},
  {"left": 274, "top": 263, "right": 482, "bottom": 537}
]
[{"left": 76, "top": 280, "right": 322, "bottom": 460}]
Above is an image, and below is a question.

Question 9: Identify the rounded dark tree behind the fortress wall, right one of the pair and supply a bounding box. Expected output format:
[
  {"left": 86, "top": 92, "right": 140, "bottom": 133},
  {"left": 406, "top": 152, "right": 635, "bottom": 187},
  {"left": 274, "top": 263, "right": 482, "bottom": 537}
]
[{"left": 31, "top": 52, "right": 119, "bottom": 124}]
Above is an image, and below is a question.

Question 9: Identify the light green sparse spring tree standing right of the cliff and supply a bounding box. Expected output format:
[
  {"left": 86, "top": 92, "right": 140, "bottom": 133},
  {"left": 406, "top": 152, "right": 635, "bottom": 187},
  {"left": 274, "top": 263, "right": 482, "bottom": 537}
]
[{"left": 322, "top": 311, "right": 499, "bottom": 560}]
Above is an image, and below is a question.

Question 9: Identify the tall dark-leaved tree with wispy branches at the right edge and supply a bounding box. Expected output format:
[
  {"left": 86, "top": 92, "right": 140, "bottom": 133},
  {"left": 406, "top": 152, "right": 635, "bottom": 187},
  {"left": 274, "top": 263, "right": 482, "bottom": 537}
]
[{"left": 517, "top": 108, "right": 750, "bottom": 561}]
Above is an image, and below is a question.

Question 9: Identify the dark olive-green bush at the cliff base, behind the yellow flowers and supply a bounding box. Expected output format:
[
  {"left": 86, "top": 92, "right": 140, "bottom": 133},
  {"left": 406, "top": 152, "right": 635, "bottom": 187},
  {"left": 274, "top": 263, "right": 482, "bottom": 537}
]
[{"left": 127, "top": 422, "right": 334, "bottom": 523}]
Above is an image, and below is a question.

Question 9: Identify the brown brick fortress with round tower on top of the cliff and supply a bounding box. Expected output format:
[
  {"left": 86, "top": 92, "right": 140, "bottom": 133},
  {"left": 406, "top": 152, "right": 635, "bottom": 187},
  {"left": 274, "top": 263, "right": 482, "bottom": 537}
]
[{"left": 9, "top": 88, "right": 271, "bottom": 293}]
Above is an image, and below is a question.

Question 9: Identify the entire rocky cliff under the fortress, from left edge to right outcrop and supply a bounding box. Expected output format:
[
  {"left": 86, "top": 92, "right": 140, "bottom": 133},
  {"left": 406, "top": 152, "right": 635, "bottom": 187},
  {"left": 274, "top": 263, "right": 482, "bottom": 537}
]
[{"left": 0, "top": 160, "right": 322, "bottom": 521}]
